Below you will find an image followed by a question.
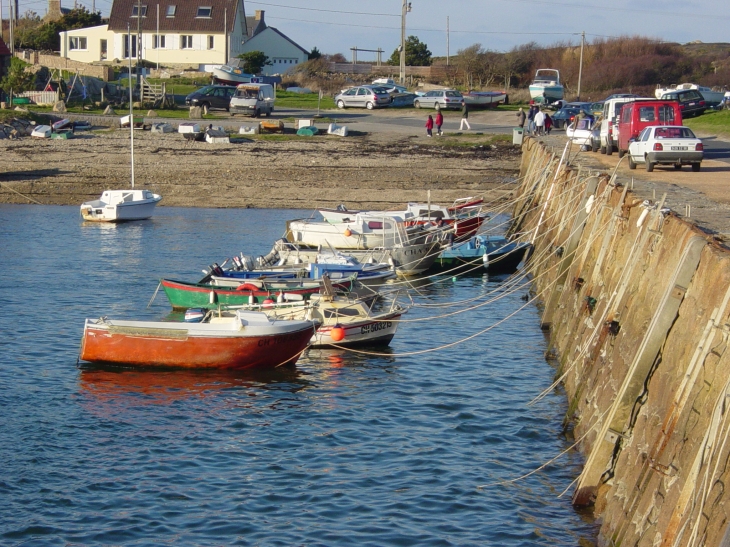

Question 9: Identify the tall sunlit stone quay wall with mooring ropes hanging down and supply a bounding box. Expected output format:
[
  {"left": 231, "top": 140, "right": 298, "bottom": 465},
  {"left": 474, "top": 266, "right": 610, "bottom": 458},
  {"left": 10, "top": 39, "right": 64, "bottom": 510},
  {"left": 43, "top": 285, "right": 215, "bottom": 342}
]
[{"left": 513, "top": 139, "right": 730, "bottom": 547}]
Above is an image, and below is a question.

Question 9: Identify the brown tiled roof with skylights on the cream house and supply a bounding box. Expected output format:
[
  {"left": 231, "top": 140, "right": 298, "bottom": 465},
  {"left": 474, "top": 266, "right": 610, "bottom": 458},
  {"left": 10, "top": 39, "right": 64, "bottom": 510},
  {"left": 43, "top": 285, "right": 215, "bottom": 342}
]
[{"left": 109, "top": 0, "right": 242, "bottom": 33}]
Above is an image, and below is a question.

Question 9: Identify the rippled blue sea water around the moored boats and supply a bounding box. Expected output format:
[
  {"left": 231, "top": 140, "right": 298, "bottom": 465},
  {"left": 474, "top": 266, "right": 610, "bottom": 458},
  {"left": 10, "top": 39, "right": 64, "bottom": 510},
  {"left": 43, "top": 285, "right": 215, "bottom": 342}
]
[{"left": 0, "top": 205, "right": 596, "bottom": 546}]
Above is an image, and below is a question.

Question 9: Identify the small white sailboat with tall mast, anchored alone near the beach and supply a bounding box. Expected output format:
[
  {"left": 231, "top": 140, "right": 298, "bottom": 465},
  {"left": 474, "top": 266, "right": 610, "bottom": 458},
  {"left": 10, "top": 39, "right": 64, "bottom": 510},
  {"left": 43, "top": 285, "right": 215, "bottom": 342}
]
[{"left": 81, "top": 36, "right": 162, "bottom": 222}]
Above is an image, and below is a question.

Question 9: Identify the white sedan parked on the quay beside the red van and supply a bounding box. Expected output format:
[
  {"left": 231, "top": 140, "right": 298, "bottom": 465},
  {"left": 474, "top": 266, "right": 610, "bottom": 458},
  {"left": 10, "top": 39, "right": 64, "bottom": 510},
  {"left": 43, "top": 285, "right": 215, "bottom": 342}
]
[{"left": 628, "top": 125, "right": 704, "bottom": 173}]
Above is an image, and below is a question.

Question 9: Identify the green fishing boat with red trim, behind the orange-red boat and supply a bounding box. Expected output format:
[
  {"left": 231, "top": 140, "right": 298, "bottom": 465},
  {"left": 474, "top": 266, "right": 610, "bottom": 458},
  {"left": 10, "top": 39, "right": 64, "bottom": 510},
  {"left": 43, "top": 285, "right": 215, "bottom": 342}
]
[{"left": 160, "top": 277, "right": 356, "bottom": 309}]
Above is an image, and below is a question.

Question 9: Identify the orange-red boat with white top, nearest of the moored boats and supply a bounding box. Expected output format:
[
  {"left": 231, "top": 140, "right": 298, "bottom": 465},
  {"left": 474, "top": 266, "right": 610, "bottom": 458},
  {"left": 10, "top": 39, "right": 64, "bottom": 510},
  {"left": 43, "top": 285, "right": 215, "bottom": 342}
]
[{"left": 80, "top": 310, "right": 316, "bottom": 369}]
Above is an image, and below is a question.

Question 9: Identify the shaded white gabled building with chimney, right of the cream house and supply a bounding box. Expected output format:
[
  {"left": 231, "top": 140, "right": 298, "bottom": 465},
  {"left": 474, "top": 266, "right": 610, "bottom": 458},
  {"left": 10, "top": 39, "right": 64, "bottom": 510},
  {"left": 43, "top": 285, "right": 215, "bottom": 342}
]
[{"left": 242, "top": 10, "right": 309, "bottom": 76}]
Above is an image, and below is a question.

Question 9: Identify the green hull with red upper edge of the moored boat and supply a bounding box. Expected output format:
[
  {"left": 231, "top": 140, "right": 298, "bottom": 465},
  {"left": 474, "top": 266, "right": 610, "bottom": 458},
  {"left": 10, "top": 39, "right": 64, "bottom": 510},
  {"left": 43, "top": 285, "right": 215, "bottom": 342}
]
[{"left": 160, "top": 279, "right": 354, "bottom": 309}]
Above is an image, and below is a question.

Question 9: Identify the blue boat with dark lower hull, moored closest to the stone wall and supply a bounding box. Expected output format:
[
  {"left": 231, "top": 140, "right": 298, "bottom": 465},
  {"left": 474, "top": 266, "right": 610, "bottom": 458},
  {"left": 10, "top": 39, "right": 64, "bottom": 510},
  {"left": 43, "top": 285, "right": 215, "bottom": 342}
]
[{"left": 434, "top": 235, "right": 530, "bottom": 275}]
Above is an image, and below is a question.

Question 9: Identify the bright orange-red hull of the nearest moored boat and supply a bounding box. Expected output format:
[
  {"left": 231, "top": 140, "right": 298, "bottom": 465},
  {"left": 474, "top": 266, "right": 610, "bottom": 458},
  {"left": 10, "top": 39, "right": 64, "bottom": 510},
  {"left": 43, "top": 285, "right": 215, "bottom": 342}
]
[{"left": 80, "top": 321, "right": 313, "bottom": 370}]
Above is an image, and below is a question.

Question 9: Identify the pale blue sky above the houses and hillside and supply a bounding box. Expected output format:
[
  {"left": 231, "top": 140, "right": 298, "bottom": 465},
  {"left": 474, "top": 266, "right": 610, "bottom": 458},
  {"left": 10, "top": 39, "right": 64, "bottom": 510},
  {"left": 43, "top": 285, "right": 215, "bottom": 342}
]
[{"left": 5, "top": 0, "right": 730, "bottom": 57}]
